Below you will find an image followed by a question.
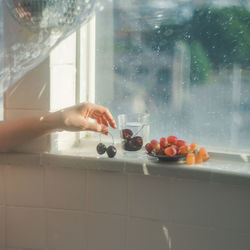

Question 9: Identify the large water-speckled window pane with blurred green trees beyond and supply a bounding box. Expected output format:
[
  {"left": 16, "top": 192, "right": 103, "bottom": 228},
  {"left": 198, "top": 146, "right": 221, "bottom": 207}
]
[{"left": 96, "top": 0, "right": 250, "bottom": 150}]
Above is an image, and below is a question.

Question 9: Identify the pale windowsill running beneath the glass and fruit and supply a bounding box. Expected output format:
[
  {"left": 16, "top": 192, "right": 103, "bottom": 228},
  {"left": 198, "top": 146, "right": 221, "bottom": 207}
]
[{"left": 0, "top": 142, "right": 250, "bottom": 186}]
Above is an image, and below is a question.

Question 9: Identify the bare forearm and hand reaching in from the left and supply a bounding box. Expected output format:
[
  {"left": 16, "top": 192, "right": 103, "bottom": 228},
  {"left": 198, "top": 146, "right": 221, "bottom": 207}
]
[{"left": 0, "top": 102, "right": 117, "bottom": 151}]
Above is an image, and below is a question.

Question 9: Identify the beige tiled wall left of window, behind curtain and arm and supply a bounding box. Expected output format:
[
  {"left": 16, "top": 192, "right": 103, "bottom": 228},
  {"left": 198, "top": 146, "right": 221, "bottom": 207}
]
[{"left": 3, "top": 1, "right": 50, "bottom": 152}]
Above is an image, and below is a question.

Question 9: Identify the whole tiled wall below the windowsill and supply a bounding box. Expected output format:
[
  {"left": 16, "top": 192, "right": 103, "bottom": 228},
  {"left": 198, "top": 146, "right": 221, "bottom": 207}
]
[{"left": 0, "top": 155, "right": 250, "bottom": 250}]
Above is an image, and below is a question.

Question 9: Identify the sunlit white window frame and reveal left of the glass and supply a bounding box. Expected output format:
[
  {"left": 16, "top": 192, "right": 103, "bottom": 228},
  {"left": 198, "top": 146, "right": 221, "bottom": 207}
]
[{"left": 50, "top": 16, "right": 96, "bottom": 151}]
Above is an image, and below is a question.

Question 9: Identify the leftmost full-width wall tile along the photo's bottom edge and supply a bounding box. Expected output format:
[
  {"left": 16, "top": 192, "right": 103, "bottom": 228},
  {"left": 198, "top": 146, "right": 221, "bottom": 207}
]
[{"left": 6, "top": 207, "right": 45, "bottom": 249}]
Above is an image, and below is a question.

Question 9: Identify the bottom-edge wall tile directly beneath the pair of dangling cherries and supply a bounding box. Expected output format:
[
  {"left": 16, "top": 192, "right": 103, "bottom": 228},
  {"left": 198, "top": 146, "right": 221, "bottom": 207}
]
[{"left": 87, "top": 214, "right": 126, "bottom": 250}]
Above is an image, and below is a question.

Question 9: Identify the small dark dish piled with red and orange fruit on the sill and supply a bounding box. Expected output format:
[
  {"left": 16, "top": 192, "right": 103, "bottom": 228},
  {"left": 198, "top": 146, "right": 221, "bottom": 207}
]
[{"left": 145, "top": 135, "right": 209, "bottom": 165}]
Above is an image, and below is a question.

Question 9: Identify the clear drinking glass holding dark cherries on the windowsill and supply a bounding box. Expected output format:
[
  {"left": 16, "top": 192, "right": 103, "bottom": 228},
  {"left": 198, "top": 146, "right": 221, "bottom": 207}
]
[{"left": 118, "top": 113, "right": 149, "bottom": 151}]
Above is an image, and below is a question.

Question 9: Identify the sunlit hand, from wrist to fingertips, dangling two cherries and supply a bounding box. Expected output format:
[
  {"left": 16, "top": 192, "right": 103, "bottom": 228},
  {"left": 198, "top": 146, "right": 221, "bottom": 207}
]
[{"left": 47, "top": 102, "right": 117, "bottom": 134}]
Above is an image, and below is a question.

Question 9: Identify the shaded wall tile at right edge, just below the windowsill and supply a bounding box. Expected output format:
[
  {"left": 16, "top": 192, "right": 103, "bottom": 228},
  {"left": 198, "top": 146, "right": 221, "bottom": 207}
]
[{"left": 212, "top": 184, "right": 250, "bottom": 233}]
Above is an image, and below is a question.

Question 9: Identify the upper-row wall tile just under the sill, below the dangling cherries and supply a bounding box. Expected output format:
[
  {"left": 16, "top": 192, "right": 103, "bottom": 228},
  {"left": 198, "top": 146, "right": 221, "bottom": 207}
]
[{"left": 88, "top": 171, "right": 128, "bottom": 215}]
